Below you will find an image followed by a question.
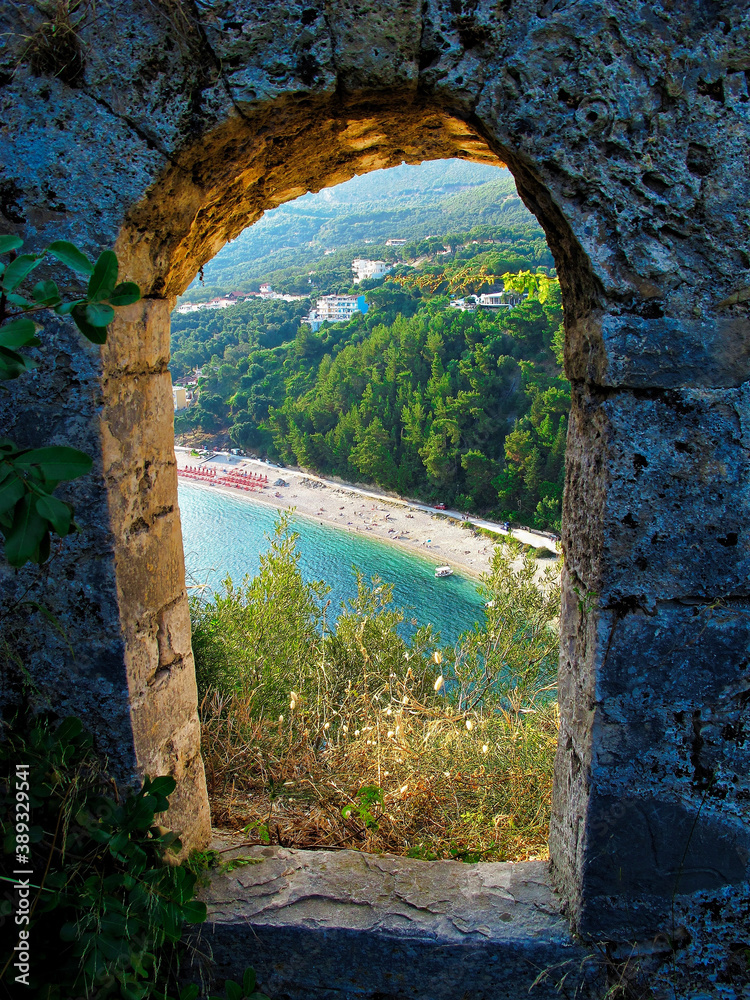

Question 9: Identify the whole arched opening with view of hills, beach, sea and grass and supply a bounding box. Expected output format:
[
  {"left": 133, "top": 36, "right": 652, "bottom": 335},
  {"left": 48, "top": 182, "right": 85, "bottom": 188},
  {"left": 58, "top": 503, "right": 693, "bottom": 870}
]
[{"left": 170, "top": 159, "right": 570, "bottom": 861}]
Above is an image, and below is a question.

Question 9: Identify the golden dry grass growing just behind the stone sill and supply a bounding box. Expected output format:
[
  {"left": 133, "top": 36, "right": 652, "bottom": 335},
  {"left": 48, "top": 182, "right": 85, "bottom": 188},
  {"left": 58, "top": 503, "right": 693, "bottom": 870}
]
[{"left": 201, "top": 672, "right": 558, "bottom": 861}]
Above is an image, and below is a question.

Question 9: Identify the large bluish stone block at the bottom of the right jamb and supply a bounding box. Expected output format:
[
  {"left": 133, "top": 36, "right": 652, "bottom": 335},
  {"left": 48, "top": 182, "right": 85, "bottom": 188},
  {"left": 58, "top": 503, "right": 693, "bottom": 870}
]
[{"left": 550, "top": 576, "right": 750, "bottom": 940}]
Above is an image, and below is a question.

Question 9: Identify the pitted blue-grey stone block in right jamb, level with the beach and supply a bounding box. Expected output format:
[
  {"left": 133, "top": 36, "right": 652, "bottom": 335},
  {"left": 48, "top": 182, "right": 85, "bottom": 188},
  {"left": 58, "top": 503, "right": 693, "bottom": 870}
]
[{"left": 564, "top": 384, "right": 750, "bottom": 607}]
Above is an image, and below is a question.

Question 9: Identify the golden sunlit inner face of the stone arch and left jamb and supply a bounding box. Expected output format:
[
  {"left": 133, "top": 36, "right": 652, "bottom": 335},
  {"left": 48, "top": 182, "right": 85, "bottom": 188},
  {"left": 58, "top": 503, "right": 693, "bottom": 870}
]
[{"left": 102, "top": 95, "right": 596, "bottom": 860}]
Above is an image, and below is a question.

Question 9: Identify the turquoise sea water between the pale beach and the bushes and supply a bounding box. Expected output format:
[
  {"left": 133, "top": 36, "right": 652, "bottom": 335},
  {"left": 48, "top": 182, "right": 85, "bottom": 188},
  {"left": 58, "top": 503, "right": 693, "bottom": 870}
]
[{"left": 179, "top": 480, "right": 490, "bottom": 643}]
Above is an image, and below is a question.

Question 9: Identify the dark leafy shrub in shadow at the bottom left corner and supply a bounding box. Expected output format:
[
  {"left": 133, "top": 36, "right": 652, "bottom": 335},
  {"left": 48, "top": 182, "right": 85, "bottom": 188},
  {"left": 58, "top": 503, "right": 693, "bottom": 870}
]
[{"left": 0, "top": 716, "right": 206, "bottom": 1000}]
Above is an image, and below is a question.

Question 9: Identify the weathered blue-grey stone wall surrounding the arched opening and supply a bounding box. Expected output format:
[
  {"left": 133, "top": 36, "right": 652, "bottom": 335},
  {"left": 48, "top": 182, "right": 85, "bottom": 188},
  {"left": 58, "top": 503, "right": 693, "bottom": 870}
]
[{"left": 0, "top": 0, "right": 750, "bottom": 952}]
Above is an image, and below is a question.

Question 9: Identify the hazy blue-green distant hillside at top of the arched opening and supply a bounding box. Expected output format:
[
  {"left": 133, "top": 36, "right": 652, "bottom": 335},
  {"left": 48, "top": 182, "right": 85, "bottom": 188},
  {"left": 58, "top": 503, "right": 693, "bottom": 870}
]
[{"left": 185, "top": 160, "right": 552, "bottom": 301}]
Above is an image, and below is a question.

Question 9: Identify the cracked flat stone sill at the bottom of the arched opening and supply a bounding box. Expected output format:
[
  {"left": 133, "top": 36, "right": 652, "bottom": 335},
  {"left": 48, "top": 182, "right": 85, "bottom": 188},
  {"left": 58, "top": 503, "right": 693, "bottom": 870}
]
[{"left": 188, "top": 839, "right": 602, "bottom": 1000}]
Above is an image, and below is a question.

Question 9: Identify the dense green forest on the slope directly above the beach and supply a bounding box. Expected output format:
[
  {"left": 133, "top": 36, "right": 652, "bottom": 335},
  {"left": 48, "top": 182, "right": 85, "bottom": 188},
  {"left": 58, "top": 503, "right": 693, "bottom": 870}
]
[{"left": 172, "top": 232, "right": 570, "bottom": 528}]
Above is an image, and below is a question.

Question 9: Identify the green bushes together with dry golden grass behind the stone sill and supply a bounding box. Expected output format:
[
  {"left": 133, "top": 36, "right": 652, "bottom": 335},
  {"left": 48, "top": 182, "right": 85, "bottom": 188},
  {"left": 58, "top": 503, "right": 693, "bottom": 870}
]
[{"left": 193, "top": 521, "right": 559, "bottom": 860}]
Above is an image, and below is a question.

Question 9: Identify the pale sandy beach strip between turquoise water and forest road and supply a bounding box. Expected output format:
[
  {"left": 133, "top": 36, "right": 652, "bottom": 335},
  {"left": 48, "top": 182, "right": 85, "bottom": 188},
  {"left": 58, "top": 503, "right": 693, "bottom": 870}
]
[{"left": 175, "top": 448, "right": 564, "bottom": 577}]
